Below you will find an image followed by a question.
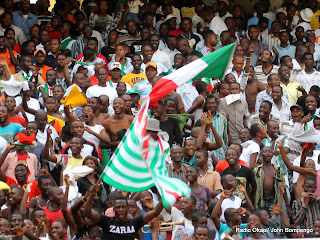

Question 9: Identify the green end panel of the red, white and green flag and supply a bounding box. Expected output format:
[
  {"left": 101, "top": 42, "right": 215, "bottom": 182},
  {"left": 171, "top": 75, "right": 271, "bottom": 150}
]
[{"left": 193, "top": 43, "right": 236, "bottom": 80}]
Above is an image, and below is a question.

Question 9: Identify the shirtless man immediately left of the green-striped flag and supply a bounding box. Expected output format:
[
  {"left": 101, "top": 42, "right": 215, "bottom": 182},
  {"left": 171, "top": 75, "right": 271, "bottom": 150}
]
[{"left": 102, "top": 97, "right": 133, "bottom": 152}]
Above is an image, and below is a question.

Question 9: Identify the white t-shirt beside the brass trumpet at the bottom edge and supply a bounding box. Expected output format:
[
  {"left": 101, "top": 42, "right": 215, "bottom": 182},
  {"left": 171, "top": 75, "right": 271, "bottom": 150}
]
[{"left": 171, "top": 207, "right": 194, "bottom": 240}]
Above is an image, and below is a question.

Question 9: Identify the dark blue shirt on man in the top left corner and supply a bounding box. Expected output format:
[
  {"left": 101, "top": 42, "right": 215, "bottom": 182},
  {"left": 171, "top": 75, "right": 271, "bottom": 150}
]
[{"left": 12, "top": 11, "right": 38, "bottom": 40}]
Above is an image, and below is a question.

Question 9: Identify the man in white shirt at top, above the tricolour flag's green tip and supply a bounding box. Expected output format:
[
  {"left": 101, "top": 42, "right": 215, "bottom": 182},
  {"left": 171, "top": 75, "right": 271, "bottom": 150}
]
[{"left": 203, "top": 6, "right": 228, "bottom": 36}]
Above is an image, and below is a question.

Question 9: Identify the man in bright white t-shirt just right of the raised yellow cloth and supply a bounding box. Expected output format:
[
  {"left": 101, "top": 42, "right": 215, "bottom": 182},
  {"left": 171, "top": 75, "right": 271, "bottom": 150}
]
[{"left": 86, "top": 67, "right": 118, "bottom": 104}]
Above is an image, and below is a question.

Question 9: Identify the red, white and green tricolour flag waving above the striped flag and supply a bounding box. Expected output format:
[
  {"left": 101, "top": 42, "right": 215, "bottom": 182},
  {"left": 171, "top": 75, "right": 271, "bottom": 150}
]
[{"left": 150, "top": 43, "right": 236, "bottom": 105}]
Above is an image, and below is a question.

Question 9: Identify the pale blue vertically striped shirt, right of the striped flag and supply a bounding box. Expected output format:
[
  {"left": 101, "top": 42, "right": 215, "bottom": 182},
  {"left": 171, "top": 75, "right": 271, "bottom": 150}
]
[{"left": 209, "top": 112, "right": 229, "bottom": 162}]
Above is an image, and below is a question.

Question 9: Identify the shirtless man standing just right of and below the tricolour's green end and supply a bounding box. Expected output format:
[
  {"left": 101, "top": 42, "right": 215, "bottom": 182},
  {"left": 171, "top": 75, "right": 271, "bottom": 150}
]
[{"left": 245, "top": 66, "right": 265, "bottom": 113}]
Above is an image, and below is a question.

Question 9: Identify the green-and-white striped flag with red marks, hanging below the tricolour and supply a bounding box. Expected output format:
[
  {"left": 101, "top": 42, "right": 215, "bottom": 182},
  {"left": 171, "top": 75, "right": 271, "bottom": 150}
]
[{"left": 101, "top": 98, "right": 190, "bottom": 207}]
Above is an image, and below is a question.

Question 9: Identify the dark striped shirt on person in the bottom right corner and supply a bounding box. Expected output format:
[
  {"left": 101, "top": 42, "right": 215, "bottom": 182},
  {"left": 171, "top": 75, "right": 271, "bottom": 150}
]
[{"left": 293, "top": 198, "right": 320, "bottom": 229}]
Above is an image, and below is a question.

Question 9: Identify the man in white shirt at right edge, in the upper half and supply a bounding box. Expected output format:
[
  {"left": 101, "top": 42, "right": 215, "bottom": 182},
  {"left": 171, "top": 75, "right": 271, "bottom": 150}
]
[{"left": 294, "top": 52, "right": 320, "bottom": 92}]
